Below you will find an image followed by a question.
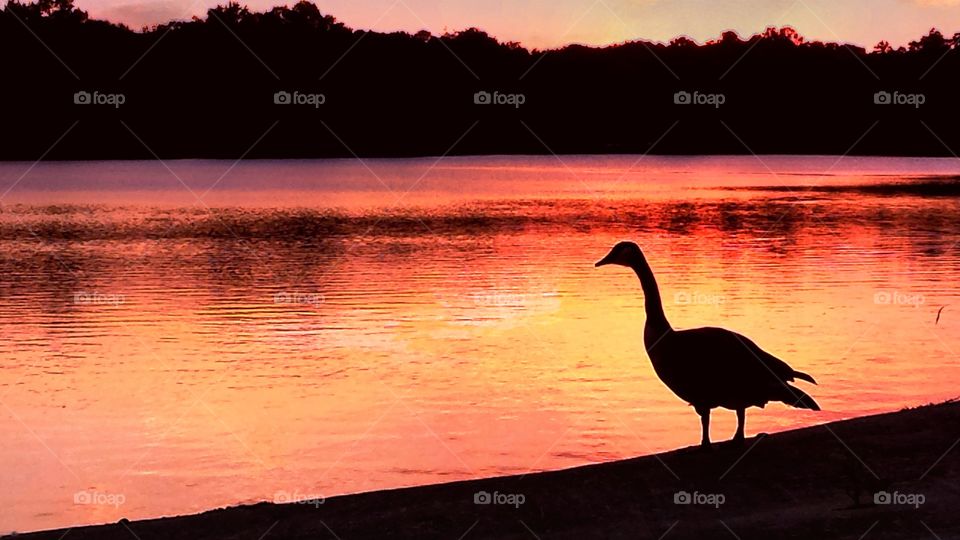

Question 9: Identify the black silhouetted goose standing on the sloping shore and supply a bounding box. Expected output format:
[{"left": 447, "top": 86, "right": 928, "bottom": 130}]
[{"left": 595, "top": 242, "right": 820, "bottom": 448}]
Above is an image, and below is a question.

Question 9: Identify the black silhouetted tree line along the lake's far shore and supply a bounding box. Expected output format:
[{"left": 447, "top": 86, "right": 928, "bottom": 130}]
[{"left": 0, "top": 0, "right": 960, "bottom": 160}]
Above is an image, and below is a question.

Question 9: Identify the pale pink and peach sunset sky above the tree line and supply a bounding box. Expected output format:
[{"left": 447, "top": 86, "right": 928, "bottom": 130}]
[{"left": 75, "top": 0, "right": 960, "bottom": 49}]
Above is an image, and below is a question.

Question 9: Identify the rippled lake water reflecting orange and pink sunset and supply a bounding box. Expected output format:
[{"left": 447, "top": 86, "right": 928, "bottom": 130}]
[{"left": 0, "top": 156, "right": 960, "bottom": 532}]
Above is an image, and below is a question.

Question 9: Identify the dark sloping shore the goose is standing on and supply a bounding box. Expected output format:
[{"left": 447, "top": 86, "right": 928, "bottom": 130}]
[{"left": 9, "top": 402, "right": 960, "bottom": 540}]
